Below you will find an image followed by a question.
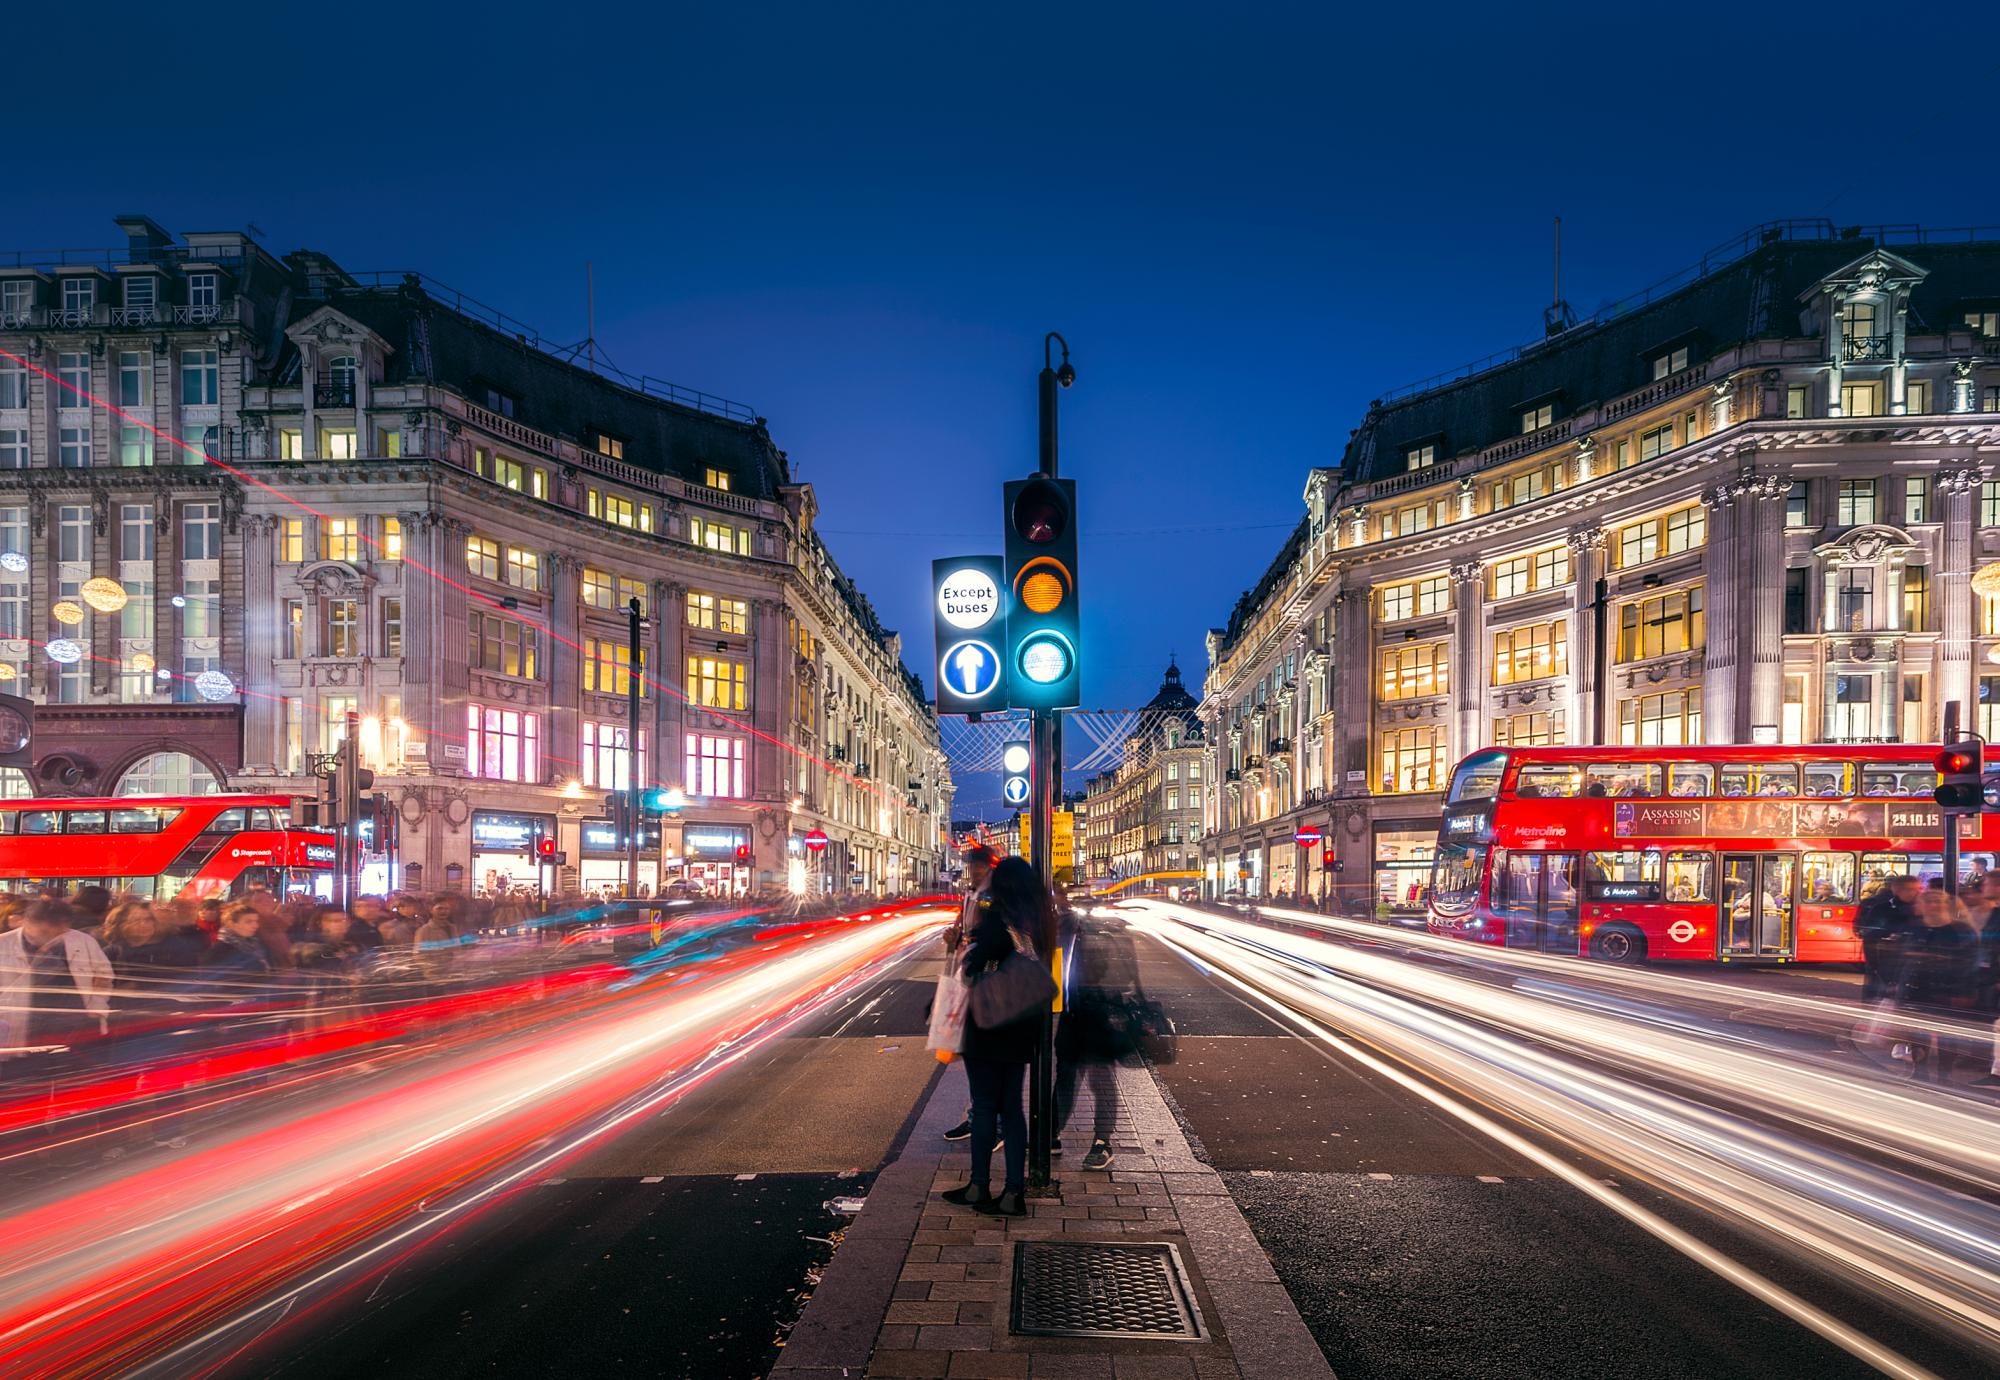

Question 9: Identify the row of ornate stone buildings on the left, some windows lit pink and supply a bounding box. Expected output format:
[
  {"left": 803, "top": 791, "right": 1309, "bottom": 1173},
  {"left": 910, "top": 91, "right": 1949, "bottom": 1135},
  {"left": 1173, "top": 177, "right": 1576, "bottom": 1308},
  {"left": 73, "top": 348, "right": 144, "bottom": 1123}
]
[{"left": 0, "top": 218, "right": 952, "bottom": 892}]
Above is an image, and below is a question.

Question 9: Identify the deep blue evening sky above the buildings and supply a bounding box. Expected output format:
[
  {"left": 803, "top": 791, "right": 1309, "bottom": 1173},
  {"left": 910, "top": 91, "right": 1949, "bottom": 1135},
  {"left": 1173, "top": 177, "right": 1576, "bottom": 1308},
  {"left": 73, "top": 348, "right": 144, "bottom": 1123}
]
[{"left": 19, "top": 4, "right": 2000, "bottom": 808}]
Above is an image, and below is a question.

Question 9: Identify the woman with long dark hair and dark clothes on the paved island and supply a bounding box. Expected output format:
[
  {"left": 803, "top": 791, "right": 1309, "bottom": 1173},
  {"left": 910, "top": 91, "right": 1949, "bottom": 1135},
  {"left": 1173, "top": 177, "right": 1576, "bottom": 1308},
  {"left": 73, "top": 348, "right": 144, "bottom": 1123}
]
[{"left": 944, "top": 858, "right": 1056, "bottom": 1218}]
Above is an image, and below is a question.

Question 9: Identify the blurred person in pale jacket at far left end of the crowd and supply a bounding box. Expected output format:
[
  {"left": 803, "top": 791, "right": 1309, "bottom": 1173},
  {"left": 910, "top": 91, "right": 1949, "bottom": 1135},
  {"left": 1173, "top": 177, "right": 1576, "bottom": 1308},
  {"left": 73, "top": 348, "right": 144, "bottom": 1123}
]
[{"left": 0, "top": 900, "right": 112, "bottom": 1074}]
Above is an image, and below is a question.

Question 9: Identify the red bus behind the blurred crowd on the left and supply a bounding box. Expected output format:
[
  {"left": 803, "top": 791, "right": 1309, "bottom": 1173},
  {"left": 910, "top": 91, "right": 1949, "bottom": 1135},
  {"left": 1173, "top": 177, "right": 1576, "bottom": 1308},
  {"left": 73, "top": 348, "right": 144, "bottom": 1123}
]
[{"left": 0, "top": 796, "right": 334, "bottom": 900}]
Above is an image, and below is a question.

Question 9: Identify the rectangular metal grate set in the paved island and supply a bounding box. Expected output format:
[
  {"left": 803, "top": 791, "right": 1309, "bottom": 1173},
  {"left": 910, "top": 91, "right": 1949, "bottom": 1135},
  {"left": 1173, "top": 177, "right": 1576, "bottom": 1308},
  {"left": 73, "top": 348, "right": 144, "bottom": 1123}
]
[{"left": 1012, "top": 1242, "right": 1202, "bottom": 1342}]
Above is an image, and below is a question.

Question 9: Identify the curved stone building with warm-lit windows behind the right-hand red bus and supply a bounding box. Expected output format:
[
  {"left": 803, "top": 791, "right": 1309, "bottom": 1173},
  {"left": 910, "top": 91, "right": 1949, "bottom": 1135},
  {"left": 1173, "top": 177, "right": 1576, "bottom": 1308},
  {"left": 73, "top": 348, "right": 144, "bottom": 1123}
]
[{"left": 1202, "top": 222, "right": 2000, "bottom": 916}]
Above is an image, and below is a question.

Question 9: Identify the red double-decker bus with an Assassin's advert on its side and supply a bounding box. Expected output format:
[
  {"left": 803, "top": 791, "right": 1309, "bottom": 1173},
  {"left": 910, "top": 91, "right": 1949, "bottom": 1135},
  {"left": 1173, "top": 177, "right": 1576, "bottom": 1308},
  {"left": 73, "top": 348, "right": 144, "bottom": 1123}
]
[{"left": 1428, "top": 744, "right": 2000, "bottom": 962}]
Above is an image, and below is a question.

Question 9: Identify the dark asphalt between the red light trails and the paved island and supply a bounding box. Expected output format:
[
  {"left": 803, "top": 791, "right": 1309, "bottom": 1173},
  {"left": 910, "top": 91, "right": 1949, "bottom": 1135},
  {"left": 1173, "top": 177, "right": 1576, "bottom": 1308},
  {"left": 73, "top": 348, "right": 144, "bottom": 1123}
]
[{"left": 222, "top": 962, "right": 938, "bottom": 1380}]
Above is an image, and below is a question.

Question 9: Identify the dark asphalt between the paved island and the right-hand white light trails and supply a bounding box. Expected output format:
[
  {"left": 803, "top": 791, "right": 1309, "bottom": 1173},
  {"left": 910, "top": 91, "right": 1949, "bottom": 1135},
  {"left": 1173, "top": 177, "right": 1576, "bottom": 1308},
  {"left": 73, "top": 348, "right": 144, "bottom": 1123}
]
[{"left": 1138, "top": 924, "right": 1984, "bottom": 1380}]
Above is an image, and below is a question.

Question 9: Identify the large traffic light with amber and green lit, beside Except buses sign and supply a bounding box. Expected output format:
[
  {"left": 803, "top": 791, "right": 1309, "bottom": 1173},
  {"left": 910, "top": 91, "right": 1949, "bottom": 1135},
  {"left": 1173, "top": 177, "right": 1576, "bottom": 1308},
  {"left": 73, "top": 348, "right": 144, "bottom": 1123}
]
[{"left": 1004, "top": 474, "right": 1082, "bottom": 710}]
